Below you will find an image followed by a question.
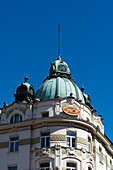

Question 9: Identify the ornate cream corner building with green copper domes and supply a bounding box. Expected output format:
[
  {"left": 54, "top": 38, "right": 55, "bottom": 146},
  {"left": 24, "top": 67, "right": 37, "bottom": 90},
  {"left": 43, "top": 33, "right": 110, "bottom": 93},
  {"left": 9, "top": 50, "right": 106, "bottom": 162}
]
[{"left": 0, "top": 57, "right": 113, "bottom": 170}]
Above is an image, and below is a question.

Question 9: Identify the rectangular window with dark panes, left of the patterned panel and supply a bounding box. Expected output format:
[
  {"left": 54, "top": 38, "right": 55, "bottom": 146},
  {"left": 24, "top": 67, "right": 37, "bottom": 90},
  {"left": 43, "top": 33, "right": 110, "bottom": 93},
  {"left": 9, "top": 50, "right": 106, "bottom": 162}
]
[{"left": 41, "top": 132, "right": 50, "bottom": 147}]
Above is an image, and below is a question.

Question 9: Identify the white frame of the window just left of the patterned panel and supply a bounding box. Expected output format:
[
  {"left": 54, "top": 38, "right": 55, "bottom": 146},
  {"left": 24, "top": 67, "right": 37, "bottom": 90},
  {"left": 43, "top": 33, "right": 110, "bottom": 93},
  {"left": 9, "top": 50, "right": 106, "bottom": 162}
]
[{"left": 40, "top": 132, "right": 50, "bottom": 148}]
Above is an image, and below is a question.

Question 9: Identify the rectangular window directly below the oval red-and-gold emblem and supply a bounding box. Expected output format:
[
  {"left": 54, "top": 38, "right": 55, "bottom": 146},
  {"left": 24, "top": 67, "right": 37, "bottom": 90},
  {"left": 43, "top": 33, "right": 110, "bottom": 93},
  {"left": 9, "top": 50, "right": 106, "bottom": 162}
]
[{"left": 67, "top": 132, "right": 76, "bottom": 147}]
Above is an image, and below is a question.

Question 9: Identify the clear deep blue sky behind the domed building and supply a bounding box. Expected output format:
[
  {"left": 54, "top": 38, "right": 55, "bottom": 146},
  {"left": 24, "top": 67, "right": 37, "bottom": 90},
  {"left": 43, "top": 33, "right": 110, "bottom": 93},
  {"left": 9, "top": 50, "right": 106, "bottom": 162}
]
[{"left": 0, "top": 0, "right": 113, "bottom": 142}]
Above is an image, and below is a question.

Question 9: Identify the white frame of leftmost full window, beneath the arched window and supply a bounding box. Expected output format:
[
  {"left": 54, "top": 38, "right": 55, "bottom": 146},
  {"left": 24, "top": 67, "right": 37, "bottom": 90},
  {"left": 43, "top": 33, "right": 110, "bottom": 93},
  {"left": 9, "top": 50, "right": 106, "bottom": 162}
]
[{"left": 9, "top": 136, "right": 19, "bottom": 152}]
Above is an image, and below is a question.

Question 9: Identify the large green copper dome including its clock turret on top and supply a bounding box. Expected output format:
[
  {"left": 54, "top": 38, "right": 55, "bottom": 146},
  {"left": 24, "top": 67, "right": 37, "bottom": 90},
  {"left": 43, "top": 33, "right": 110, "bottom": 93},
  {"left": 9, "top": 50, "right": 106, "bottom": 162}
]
[{"left": 35, "top": 58, "right": 85, "bottom": 103}]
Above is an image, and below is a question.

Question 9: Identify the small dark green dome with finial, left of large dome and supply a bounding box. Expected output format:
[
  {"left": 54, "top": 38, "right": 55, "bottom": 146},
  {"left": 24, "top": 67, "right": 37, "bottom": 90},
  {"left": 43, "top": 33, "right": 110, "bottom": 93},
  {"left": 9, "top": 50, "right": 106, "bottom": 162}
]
[{"left": 14, "top": 76, "right": 34, "bottom": 103}]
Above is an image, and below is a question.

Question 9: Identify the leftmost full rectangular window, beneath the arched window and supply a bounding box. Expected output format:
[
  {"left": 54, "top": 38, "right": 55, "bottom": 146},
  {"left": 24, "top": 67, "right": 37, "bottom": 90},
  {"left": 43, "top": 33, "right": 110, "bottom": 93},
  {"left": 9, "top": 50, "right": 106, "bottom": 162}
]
[{"left": 10, "top": 137, "right": 19, "bottom": 152}]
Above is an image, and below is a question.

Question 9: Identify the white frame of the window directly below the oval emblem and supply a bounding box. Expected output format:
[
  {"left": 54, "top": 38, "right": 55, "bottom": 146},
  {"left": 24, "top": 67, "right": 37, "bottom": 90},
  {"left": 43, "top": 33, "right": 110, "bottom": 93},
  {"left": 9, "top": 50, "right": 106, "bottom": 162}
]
[{"left": 66, "top": 131, "right": 76, "bottom": 147}]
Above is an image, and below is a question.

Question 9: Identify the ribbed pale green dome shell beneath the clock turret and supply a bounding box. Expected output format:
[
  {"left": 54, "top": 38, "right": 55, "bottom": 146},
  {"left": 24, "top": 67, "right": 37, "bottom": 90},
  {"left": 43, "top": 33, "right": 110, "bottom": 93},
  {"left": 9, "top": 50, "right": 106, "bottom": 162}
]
[{"left": 35, "top": 77, "right": 84, "bottom": 103}]
